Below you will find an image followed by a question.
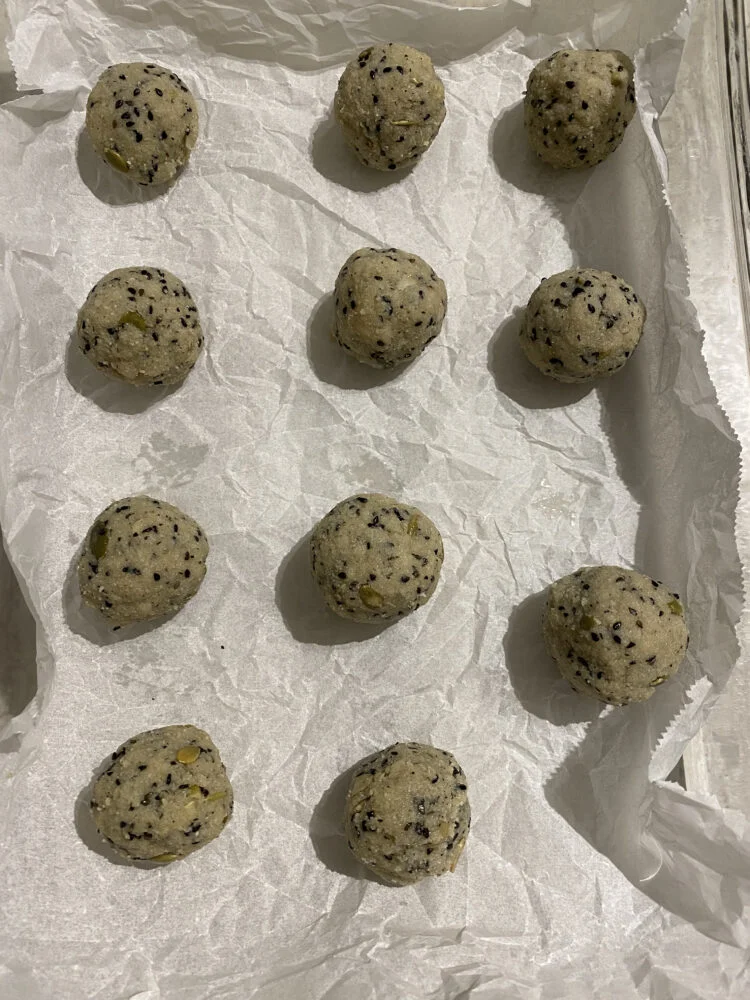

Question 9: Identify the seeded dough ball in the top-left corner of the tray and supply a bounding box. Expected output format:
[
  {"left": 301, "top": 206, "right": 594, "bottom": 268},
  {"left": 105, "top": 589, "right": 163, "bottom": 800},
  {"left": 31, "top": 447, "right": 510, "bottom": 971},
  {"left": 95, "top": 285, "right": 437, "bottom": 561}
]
[{"left": 86, "top": 63, "right": 198, "bottom": 184}]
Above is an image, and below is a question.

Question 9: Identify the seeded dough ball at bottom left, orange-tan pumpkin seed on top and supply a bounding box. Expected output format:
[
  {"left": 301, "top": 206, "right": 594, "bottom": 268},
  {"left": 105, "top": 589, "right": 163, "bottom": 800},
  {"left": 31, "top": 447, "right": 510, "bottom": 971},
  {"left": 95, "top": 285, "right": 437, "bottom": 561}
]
[{"left": 91, "top": 726, "right": 233, "bottom": 862}]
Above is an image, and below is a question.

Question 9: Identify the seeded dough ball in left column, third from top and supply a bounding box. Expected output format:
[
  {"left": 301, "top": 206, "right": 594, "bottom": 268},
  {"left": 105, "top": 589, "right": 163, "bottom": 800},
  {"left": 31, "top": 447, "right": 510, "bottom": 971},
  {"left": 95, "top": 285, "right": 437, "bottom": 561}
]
[{"left": 78, "top": 496, "right": 208, "bottom": 627}]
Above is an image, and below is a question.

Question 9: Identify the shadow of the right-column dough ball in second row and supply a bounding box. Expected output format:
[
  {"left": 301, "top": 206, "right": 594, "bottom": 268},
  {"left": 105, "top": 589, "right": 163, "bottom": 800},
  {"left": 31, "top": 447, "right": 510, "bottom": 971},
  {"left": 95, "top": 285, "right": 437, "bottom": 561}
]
[{"left": 487, "top": 306, "right": 594, "bottom": 410}]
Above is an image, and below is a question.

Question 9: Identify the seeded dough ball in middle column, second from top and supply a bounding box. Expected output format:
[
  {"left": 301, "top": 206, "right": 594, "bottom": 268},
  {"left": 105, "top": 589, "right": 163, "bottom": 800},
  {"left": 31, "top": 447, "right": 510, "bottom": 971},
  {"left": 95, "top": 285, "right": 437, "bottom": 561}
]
[{"left": 334, "top": 247, "right": 447, "bottom": 368}]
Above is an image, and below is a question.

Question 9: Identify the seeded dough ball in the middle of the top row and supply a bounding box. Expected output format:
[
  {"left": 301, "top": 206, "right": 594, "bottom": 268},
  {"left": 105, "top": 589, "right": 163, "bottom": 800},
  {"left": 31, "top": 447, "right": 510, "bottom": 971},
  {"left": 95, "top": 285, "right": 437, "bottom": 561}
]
[{"left": 333, "top": 42, "right": 445, "bottom": 170}]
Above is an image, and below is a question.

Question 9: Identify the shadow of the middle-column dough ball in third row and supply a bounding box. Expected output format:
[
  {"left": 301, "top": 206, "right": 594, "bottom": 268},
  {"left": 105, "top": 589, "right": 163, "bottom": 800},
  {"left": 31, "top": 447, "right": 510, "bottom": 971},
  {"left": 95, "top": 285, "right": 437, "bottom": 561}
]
[{"left": 276, "top": 531, "right": 395, "bottom": 646}]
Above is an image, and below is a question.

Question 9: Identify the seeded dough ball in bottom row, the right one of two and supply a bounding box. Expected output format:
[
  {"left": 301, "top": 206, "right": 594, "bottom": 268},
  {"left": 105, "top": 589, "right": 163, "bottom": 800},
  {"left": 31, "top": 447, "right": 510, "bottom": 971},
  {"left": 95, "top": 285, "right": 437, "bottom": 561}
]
[{"left": 344, "top": 743, "right": 471, "bottom": 885}]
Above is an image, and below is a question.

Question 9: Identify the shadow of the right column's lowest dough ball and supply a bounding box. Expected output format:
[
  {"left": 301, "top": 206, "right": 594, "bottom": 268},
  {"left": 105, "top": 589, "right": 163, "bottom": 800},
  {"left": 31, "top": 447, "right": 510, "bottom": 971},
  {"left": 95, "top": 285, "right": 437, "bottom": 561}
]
[{"left": 503, "top": 590, "right": 604, "bottom": 726}]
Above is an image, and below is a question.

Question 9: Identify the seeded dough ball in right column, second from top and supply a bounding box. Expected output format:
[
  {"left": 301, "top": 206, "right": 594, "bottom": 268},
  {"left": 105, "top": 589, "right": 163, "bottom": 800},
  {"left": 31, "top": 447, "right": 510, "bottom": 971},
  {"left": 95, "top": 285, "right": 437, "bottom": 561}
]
[{"left": 520, "top": 268, "right": 646, "bottom": 382}]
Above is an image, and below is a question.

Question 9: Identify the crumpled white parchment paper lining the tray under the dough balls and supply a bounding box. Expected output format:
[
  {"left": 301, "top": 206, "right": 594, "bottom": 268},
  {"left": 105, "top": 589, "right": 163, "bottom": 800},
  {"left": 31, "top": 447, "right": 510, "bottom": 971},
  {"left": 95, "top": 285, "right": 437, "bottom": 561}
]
[{"left": 0, "top": 0, "right": 750, "bottom": 1000}]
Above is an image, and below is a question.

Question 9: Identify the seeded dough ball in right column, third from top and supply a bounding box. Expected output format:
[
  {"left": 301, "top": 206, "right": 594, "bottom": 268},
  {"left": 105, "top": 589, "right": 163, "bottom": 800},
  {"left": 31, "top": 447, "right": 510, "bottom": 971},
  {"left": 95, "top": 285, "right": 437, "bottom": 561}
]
[{"left": 544, "top": 566, "right": 688, "bottom": 705}]
